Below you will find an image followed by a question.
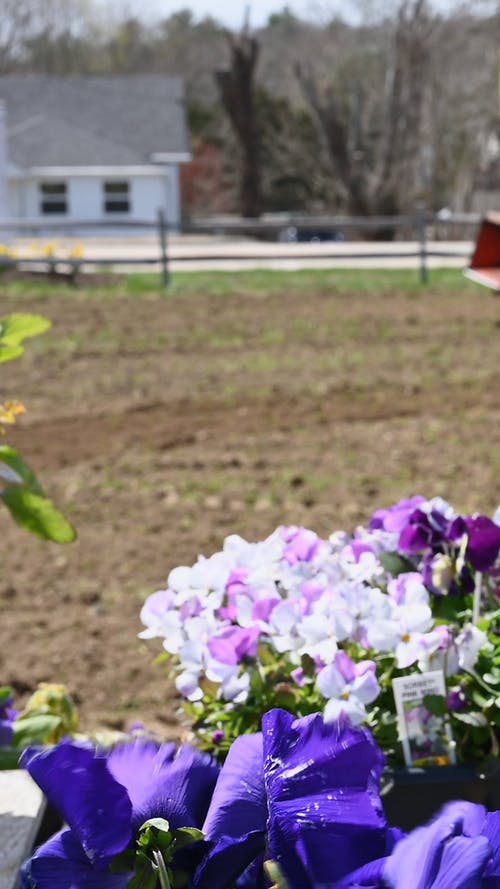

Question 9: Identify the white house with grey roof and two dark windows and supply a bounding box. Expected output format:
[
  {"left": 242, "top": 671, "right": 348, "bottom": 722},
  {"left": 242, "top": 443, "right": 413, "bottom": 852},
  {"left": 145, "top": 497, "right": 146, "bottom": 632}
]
[{"left": 0, "top": 75, "right": 190, "bottom": 226}]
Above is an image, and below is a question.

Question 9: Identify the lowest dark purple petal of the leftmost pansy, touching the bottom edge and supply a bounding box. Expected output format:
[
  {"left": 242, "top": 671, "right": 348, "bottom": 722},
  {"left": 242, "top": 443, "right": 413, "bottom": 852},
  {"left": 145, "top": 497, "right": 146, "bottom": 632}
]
[{"left": 20, "top": 828, "right": 131, "bottom": 889}]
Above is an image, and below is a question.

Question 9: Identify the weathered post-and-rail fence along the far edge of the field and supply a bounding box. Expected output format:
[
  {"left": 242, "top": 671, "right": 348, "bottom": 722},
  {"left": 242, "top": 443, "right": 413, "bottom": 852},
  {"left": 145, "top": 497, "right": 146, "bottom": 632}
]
[{"left": 0, "top": 206, "right": 481, "bottom": 286}]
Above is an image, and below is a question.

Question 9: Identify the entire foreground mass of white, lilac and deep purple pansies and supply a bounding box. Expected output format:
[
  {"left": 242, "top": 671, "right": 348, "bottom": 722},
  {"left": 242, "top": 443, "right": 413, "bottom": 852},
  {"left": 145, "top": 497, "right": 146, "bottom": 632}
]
[{"left": 11, "top": 497, "right": 500, "bottom": 889}]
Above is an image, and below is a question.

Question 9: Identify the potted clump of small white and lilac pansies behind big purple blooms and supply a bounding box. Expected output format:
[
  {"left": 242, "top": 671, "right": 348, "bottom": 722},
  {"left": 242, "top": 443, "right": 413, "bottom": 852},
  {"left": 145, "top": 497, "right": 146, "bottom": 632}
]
[{"left": 140, "top": 497, "right": 500, "bottom": 765}]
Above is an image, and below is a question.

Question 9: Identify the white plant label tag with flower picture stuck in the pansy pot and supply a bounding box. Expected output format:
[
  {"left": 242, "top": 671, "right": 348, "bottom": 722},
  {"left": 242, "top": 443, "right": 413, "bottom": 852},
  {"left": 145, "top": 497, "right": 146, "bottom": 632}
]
[{"left": 392, "top": 670, "right": 455, "bottom": 768}]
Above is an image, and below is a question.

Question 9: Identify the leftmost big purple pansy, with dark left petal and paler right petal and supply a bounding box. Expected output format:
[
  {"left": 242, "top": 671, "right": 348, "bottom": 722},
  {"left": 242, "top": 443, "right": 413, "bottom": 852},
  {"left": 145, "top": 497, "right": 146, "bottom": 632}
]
[{"left": 20, "top": 740, "right": 219, "bottom": 889}]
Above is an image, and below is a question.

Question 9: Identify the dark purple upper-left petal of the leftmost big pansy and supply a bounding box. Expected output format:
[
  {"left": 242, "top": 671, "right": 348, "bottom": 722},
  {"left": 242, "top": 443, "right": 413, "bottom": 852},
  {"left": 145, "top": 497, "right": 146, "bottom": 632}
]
[{"left": 20, "top": 741, "right": 132, "bottom": 867}]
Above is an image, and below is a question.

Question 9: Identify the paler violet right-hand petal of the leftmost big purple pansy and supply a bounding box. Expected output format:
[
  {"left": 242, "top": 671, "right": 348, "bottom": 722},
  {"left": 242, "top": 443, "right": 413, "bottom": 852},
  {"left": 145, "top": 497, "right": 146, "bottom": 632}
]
[{"left": 132, "top": 744, "right": 219, "bottom": 829}]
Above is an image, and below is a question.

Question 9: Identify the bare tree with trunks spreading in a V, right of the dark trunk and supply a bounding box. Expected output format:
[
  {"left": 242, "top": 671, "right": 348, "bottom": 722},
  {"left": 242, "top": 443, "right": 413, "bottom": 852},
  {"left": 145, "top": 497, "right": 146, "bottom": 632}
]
[{"left": 295, "top": 0, "right": 434, "bottom": 216}]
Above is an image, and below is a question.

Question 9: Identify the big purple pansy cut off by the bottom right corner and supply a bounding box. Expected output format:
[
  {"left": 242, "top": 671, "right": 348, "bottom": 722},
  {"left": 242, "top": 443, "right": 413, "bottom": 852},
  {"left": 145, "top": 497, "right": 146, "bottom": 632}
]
[{"left": 333, "top": 802, "right": 500, "bottom": 889}]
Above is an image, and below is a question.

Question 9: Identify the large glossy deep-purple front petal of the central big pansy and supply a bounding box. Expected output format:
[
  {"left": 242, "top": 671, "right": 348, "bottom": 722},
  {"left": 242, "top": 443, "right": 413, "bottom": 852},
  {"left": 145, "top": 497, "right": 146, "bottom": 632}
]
[{"left": 262, "top": 710, "right": 386, "bottom": 885}]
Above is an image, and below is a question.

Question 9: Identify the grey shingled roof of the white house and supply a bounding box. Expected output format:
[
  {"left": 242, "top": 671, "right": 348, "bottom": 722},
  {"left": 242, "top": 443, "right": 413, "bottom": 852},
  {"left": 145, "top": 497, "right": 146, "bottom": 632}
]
[{"left": 0, "top": 75, "right": 189, "bottom": 169}]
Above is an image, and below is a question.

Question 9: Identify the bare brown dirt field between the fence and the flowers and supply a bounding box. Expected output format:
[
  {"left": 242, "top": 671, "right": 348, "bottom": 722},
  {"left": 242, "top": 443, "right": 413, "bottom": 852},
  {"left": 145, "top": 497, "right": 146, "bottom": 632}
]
[{"left": 0, "top": 272, "right": 500, "bottom": 736}]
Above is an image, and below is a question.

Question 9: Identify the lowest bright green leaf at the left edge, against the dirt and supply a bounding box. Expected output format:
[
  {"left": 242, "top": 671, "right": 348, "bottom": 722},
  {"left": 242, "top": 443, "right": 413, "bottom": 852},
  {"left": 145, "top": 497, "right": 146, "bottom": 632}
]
[{"left": 0, "top": 485, "right": 76, "bottom": 543}]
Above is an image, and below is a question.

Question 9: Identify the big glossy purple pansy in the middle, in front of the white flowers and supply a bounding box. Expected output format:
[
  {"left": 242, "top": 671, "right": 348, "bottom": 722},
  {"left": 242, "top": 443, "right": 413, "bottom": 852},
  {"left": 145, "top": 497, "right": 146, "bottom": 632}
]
[{"left": 194, "top": 710, "right": 387, "bottom": 889}]
